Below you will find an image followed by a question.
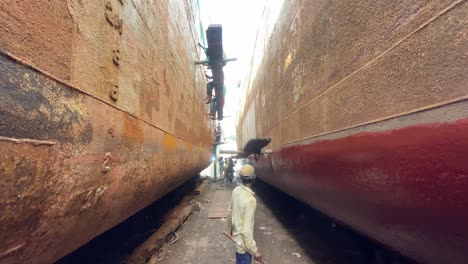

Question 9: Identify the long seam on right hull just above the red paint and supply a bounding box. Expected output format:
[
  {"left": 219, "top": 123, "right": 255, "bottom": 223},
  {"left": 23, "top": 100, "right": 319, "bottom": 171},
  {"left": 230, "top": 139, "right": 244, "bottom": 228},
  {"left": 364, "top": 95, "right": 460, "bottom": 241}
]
[{"left": 272, "top": 95, "right": 468, "bottom": 149}]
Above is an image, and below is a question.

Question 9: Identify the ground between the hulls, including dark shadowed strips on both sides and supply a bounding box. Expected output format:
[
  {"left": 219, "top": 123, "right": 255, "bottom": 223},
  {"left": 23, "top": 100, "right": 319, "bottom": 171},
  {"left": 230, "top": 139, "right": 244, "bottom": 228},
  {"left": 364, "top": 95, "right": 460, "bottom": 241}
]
[{"left": 58, "top": 178, "right": 411, "bottom": 264}]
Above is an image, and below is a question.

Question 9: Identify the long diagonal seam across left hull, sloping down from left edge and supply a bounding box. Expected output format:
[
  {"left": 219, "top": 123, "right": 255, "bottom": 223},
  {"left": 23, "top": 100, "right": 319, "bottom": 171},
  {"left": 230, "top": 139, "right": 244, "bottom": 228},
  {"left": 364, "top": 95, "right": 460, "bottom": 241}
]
[{"left": 0, "top": 49, "right": 199, "bottom": 146}]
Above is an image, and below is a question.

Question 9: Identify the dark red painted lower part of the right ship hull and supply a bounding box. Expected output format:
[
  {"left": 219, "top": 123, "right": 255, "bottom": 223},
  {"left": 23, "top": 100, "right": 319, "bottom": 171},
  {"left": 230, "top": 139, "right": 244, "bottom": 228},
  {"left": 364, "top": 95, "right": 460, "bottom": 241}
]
[{"left": 256, "top": 110, "right": 468, "bottom": 263}]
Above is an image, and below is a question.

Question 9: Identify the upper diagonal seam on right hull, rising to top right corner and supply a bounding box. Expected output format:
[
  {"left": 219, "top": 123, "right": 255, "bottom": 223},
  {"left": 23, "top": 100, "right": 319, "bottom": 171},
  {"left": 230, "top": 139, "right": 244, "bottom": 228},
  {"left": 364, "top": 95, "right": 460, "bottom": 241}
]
[{"left": 268, "top": 0, "right": 466, "bottom": 135}]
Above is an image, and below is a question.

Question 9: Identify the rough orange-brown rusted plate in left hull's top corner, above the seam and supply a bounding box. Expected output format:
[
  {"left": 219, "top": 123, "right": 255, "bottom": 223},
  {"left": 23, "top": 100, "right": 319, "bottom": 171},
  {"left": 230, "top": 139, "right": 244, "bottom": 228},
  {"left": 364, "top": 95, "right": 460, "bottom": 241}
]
[{"left": 0, "top": 0, "right": 73, "bottom": 80}]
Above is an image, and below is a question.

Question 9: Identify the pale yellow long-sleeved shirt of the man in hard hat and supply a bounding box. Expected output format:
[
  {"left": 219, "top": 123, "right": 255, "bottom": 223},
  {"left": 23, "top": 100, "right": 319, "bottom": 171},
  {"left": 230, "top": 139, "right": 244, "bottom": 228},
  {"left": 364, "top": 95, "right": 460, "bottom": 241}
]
[{"left": 227, "top": 185, "right": 257, "bottom": 254}]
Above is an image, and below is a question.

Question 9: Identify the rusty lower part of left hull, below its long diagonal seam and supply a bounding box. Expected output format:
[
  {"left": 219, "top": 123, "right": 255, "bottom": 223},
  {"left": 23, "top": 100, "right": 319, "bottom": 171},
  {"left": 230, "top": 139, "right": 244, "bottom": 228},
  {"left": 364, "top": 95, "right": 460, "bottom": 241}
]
[{"left": 0, "top": 51, "right": 210, "bottom": 263}]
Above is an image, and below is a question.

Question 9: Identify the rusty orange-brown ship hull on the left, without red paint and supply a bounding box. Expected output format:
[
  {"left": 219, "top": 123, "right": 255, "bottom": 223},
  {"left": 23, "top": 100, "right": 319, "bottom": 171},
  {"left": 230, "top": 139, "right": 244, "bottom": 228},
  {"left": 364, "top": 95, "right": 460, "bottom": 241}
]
[{"left": 0, "top": 0, "right": 213, "bottom": 263}]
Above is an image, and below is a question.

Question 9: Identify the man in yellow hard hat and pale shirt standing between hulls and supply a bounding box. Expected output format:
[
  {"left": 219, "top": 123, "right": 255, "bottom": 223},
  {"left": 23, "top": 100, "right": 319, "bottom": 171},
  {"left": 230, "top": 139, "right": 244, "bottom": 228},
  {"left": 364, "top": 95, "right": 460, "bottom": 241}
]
[{"left": 227, "top": 164, "right": 262, "bottom": 264}]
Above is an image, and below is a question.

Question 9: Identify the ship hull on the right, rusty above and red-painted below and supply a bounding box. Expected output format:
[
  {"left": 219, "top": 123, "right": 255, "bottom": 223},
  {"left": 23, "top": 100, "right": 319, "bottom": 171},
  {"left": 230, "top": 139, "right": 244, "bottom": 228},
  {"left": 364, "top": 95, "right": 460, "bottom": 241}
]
[{"left": 237, "top": 0, "right": 468, "bottom": 264}]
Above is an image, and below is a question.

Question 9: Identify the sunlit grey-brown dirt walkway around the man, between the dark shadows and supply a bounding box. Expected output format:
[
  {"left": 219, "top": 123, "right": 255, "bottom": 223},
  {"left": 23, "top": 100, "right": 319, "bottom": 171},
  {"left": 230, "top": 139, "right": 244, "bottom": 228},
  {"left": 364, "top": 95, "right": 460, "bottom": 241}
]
[{"left": 160, "top": 183, "right": 315, "bottom": 264}]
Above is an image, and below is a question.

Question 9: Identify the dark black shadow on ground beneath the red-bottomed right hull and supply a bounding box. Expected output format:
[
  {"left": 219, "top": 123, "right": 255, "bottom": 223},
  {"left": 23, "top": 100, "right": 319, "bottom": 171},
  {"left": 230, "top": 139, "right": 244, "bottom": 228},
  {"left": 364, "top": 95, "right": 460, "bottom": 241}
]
[{"left": 254, "top": 180, "right": 416, "bottom": 264}]
